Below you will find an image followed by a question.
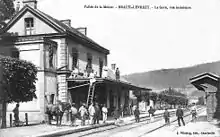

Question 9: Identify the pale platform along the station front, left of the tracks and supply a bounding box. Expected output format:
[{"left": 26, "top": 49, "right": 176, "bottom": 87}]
[{"left": 0, "top": 109, "right": 175, "bottom": 137}]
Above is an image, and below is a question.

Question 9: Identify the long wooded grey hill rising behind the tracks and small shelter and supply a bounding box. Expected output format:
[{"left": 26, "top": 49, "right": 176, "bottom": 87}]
[{"left": 123, "top": 61, "right": 220, "bottom": 96}]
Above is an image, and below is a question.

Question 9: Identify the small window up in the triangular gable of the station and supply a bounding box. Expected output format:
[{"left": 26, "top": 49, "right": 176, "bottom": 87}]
[{"left": 24, "top": 18, "right": 34, "bottom": 35}]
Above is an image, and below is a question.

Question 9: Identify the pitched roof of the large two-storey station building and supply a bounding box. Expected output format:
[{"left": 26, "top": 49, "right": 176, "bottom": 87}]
[{"left": 5, "top": 5, "right": 109, "bottom": 54}]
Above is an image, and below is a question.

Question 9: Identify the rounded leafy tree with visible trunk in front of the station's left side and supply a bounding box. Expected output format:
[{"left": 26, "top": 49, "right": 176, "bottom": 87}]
[{"left": 0, "top": 57, "right": 37, "bottom": 128}]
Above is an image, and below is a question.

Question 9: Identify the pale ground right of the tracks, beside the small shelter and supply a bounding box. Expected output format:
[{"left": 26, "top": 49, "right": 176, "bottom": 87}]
[{"left": 146, "top": 111, "right": 220, "bottom": 137}]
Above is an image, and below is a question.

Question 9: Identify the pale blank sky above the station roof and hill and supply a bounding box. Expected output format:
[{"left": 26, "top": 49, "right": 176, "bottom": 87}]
[{"left": 34, "top": 0, "right": 220, "bottom": 74}]
